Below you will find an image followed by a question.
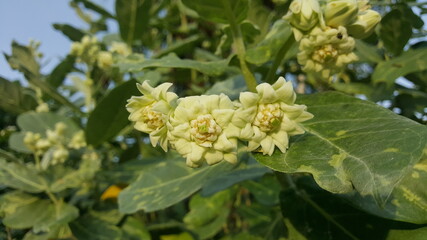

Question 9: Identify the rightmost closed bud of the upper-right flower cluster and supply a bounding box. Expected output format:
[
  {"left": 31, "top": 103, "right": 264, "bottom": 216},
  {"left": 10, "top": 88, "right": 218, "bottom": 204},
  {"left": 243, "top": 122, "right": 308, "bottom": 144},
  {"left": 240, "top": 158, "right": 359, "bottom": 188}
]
[{"left": 347, "top": 10, "right": 381, "bottom": 39}]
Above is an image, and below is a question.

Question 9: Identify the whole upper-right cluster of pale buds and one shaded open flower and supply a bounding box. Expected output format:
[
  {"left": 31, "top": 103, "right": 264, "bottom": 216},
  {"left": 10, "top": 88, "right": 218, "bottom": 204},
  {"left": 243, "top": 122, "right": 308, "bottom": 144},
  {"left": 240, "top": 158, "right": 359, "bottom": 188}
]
[{"left": 284, "top": 0, "right": 381, "bottom": 81}]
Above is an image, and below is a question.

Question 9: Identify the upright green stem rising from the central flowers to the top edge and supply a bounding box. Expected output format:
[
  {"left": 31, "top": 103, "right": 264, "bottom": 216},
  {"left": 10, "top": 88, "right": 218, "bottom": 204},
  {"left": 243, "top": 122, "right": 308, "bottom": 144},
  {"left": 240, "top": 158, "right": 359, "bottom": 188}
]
[{"left": 222, "top": 0, "right": 257, "bottom": 92}]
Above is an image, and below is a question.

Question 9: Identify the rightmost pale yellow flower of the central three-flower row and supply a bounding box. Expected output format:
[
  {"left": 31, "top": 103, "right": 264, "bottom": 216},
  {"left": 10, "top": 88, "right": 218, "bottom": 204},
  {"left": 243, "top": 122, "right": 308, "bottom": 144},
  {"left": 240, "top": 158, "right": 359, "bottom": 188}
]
[{"left": 233, "top": 77, "right": 313, "bottom": 155}]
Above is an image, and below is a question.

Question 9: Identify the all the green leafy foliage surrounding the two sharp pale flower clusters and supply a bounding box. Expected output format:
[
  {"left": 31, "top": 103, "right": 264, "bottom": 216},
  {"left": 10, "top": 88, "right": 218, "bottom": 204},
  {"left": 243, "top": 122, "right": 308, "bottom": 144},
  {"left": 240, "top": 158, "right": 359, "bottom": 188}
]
[{"left": 0, "top": 0, "right": 427, "bottom": 240}]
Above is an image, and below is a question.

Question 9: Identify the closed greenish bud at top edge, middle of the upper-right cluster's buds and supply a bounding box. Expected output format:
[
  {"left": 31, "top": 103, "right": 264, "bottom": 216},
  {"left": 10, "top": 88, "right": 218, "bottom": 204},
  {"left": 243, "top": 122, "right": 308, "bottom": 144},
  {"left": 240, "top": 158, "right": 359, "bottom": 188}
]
[{"left": 325, "top": 0, "right": 359, "bottom": 27}]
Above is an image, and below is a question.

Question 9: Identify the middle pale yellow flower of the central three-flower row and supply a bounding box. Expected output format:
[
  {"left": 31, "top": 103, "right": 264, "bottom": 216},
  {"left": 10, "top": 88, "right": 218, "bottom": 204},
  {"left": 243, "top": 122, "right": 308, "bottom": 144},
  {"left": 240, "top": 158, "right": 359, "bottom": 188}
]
[{"left": 168, "top": 94, "right": 238, "bottom": 167}]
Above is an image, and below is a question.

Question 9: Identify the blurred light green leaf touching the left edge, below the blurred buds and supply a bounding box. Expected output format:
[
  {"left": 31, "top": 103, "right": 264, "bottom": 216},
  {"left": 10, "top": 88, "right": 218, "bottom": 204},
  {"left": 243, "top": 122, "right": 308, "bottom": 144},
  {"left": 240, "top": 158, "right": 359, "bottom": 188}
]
[{"left": 0, "top": 158, "right": 47, "bottom": 193}]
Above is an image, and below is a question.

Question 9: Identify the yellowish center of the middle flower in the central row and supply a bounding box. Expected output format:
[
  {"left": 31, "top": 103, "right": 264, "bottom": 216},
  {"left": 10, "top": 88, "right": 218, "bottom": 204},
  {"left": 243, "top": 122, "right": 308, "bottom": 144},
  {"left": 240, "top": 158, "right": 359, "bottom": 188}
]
[{"left": 190, "top": 114, "right": 222, "bottom": 147}]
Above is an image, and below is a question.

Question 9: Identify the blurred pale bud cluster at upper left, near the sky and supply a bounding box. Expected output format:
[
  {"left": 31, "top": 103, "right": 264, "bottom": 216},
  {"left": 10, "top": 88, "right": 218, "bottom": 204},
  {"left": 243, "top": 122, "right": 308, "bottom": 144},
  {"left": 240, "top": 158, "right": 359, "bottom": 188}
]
[{"left": 70, "top": 36, "right": 132, "bottom": 70}]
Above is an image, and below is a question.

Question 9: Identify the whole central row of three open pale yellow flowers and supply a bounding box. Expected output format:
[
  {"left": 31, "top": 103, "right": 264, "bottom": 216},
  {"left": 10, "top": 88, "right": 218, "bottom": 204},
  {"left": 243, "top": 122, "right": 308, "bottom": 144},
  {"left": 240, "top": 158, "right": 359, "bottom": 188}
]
[{"left": 126, "top": 77, "right": 313, "bottom": 167}]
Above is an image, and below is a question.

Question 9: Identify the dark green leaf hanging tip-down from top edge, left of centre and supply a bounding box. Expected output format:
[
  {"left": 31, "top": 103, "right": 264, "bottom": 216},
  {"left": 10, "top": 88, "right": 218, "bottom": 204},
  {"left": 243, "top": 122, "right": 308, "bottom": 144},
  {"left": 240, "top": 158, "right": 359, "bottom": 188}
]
[{"left": 116, "top": 0, "right": 152, "bottom": 45}]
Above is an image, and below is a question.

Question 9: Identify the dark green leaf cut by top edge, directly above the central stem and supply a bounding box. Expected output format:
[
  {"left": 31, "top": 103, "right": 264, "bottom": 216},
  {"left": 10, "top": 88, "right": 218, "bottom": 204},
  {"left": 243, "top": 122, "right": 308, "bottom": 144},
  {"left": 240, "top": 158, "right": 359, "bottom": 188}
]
[{"left": 182, "top": 0, "right": 249, "bottom": 24}]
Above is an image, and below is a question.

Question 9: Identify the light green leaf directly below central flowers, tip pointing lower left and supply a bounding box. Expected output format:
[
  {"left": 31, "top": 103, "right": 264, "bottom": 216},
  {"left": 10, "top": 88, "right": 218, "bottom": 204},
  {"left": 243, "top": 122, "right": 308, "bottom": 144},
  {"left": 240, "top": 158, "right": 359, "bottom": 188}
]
[{"left": 118, "top": 158, "right": 234, "bottom": 213}]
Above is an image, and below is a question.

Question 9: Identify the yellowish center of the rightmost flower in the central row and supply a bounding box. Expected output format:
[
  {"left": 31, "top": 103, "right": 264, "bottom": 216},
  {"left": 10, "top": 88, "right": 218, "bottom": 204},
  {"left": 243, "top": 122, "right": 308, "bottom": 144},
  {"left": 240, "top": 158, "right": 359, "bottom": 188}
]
[{"left": 253, "top": 103, "right": 283, "bottom": 132}]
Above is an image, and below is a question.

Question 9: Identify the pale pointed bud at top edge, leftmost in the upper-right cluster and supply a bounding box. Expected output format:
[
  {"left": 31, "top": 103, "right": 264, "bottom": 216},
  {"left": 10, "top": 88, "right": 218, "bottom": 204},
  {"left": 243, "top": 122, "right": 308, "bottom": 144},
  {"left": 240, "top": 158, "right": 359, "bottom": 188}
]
[{"left": 284, "top": 0, "right": 321, "bottom": 32}]
